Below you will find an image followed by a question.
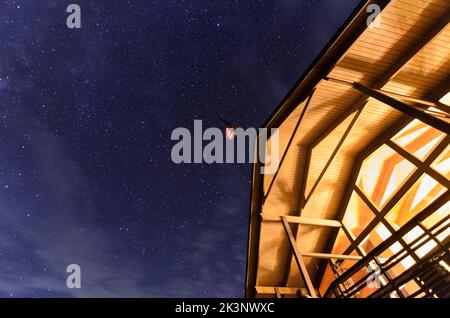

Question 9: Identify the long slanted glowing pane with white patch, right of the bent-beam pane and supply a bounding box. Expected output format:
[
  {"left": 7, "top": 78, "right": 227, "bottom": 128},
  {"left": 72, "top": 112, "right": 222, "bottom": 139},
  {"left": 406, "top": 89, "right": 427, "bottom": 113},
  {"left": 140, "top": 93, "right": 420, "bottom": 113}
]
[{"left": 386, "top": 174, "right": 446, "bottom": 229}]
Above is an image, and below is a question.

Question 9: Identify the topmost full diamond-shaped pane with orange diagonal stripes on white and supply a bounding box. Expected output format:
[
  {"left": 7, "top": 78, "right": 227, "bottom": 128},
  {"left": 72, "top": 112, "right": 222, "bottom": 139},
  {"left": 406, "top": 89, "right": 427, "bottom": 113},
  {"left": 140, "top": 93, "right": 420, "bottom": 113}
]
[{"left": 392, "top": 119, "right": 445, "bottom": 161}]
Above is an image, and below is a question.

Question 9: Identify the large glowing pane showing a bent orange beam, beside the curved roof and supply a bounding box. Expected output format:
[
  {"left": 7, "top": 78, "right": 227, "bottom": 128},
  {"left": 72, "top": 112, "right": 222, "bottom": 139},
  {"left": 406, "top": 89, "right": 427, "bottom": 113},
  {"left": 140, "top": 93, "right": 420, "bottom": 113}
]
[{"left": 357, "top": 145, "right": 416, "bottom": 209}]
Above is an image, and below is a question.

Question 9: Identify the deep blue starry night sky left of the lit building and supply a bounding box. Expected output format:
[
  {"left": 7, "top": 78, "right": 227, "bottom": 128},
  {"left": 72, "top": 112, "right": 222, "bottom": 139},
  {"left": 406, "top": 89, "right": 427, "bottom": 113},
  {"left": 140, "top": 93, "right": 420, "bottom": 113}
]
[{"left": 0, "top": 0, "right": 359, "bottom": 297}]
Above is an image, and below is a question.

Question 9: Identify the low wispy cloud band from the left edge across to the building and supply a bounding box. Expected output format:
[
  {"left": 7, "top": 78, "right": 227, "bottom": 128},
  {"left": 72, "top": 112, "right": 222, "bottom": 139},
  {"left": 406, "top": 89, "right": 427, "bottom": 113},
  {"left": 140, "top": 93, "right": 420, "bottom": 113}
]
[{"left": 0, "top": 116, "right": 247, "bottom": 297}]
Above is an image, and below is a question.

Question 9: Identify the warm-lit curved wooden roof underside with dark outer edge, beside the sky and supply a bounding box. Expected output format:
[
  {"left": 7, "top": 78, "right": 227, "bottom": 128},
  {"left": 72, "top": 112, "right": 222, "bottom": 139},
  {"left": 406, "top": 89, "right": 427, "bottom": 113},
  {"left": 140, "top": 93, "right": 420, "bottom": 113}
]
[{"left": 246, "top": 0, "right": 450, "bottom": 297}]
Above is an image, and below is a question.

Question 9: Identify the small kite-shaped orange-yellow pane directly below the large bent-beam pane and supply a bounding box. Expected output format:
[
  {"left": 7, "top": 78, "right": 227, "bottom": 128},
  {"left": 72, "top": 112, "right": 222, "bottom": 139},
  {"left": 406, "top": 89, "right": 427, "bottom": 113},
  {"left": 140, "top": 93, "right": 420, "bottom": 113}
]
[{"left": 342, "top": 191, "right": 375, "bottom": 238}]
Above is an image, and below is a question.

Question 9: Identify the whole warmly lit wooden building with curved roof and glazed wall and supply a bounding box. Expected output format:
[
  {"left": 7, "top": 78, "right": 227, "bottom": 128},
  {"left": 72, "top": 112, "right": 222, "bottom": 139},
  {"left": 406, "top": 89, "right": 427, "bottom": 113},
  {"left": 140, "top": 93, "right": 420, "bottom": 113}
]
[{"left": 246, "top": 0, "right": 450, "bottom": 297}]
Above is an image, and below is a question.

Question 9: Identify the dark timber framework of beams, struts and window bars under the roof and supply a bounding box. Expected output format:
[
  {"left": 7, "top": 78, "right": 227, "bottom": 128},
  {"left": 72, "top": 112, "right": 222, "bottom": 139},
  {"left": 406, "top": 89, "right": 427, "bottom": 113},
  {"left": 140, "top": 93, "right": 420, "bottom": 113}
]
[{"left": 255, "top": 77, "right": 450, "bottom": 298}]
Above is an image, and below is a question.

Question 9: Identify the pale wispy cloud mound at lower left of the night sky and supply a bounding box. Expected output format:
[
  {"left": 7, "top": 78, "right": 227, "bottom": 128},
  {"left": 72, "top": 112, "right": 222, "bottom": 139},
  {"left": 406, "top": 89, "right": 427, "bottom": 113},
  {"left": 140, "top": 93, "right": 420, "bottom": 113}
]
[{"left": 0, "top": 113, "right": 151, "bottom": 297}]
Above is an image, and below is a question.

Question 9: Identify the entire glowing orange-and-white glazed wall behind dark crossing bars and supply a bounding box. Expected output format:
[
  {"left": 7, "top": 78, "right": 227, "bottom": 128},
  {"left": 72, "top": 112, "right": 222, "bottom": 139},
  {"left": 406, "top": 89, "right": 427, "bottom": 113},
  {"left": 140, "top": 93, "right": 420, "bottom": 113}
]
[{"left": 327, "top": 117, "right": 450, "bottom": 297}]
